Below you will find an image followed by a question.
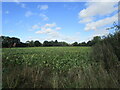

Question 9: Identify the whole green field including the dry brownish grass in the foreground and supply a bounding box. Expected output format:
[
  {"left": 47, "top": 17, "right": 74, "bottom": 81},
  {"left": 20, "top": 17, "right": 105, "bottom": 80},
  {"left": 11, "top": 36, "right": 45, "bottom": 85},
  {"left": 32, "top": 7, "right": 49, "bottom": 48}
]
[{"left": 2, "top": 47, "right": 118, "bottom": 88}]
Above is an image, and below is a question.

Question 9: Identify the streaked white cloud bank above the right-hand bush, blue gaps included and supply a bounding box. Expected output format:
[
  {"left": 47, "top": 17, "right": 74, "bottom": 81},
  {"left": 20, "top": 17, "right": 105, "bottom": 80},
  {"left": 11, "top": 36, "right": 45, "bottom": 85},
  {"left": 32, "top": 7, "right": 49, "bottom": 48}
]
[{"left": 78, "top": 0, "right": 118, "bottom": 41}]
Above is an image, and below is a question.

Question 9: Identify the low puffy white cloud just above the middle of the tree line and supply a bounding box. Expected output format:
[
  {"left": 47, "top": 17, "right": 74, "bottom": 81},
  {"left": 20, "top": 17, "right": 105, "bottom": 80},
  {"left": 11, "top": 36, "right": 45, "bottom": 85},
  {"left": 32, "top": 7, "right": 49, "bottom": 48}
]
[{"left": 35, "top": 23, "right": 80, "bottom": 43}]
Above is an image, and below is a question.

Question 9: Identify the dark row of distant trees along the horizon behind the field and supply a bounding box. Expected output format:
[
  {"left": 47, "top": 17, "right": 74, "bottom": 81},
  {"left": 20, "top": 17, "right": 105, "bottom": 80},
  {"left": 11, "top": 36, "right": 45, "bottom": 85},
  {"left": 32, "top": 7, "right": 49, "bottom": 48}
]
[{"left": 0, "top": 36, "right": 102, "bottom": 48}]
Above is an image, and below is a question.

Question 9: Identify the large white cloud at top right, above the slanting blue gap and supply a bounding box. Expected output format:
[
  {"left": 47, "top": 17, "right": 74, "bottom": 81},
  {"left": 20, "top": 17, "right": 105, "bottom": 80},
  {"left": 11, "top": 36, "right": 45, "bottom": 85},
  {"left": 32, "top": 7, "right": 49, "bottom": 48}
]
[{"left": 78, "top": 2, "right": 118, "bottom": 22}]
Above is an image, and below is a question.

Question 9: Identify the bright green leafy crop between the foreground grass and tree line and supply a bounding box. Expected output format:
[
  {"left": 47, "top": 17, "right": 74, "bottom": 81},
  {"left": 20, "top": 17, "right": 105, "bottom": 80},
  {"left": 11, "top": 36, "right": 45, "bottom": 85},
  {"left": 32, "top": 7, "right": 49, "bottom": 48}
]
[{"left": 3, "top": 47, "right": 90, "bottom": 70}]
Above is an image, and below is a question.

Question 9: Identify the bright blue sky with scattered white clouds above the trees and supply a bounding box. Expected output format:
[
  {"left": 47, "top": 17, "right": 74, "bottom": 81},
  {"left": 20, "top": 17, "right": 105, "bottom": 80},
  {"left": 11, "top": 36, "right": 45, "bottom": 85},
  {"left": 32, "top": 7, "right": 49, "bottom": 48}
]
[{"left": 2, "top": 2, "right": 118, "bottom": 43}]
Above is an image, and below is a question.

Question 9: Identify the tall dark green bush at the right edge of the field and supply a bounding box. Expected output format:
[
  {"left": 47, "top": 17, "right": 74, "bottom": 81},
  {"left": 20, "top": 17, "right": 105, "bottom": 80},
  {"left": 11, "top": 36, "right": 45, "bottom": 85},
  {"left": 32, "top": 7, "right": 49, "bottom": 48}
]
[{"left": 93, "top": 26, "right": 120, "bottom": 75}]
